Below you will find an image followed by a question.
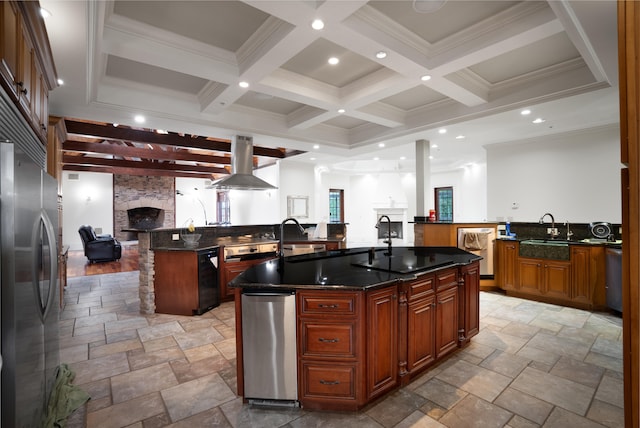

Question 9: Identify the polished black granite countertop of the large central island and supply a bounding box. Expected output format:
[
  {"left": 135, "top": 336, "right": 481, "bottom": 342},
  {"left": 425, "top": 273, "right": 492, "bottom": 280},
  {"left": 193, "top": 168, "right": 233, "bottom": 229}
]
[{"left": 229, "top": 247, "right": 481, "bottom": 290}]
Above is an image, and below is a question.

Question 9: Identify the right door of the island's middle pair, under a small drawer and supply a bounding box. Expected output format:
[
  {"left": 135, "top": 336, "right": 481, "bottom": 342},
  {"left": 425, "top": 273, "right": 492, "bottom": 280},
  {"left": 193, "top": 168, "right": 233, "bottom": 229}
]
[{"left": 436, "top": 287, "right": 459, "bottom": 358}]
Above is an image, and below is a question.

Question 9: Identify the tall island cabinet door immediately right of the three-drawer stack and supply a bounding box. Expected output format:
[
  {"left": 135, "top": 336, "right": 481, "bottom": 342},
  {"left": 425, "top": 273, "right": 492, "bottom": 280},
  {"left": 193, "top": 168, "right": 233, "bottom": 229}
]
[{"left": 366, "top": 285, "right": 398, "bottom": 399}]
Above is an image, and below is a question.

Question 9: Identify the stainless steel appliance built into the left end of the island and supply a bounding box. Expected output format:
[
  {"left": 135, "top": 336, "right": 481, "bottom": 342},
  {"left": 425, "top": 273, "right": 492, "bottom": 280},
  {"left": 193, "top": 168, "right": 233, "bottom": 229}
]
[{"left": 242, "top": 291, "right": 298, "bottom": 406}]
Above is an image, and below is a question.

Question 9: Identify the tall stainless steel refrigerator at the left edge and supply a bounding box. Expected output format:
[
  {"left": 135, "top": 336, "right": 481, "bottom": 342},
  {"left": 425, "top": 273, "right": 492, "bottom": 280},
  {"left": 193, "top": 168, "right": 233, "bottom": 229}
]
[{"left": 0, "top": 138, "right": 59, "bottom": 427}]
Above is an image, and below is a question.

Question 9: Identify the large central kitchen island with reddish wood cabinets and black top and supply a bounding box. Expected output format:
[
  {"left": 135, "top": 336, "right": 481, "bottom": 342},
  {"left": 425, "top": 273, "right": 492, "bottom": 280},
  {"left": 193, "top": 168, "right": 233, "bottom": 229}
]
[{"left": 229, "top": 247, "right": 480, "bottom": 411}]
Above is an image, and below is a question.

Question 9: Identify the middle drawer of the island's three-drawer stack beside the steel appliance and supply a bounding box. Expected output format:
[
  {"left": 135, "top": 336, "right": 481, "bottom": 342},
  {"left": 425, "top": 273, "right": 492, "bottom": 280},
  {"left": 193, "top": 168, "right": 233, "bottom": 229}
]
[{"left": 300, "top": 321, "right": 356, "bottom": 358}]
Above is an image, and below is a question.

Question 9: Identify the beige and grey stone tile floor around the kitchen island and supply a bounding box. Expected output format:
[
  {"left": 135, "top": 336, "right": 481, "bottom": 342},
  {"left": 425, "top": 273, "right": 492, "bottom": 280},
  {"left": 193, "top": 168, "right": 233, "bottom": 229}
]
[{"left": 61, "top": 272, "right": 624, "bottom": 428}]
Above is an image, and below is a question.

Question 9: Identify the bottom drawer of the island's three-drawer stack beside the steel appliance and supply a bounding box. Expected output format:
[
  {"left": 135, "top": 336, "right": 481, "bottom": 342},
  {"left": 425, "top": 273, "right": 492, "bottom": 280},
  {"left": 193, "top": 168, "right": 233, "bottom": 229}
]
[{"left": 302, "top": 362, "right": 356, "bottom": 399}]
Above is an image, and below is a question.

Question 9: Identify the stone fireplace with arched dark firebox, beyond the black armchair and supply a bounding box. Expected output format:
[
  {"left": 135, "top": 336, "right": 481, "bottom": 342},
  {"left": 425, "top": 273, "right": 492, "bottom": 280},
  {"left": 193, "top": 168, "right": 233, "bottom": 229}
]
[{"left": 113, "top": 175, "right": 175, "bottom": 241}]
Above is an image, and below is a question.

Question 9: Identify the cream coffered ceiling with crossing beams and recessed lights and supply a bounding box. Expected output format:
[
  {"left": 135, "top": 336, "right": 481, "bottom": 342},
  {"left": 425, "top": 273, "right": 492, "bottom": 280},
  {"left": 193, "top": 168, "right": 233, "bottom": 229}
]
[{"left": 40, "top": 0, "right": 618, "bottom": 176}]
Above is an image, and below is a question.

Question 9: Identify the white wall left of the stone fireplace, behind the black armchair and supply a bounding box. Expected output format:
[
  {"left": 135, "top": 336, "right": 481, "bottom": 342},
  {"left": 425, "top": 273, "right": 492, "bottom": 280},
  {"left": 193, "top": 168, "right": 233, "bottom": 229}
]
[{"left": 62, "top": 171, "right": 114, "bottom": 250}]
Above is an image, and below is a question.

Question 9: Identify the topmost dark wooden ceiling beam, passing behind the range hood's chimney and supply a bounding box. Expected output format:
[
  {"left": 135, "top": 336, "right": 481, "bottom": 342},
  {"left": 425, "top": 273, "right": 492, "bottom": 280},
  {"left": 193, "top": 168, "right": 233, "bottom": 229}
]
[{"left": 65, "top": 119, "right": 286, "bottom": 159}]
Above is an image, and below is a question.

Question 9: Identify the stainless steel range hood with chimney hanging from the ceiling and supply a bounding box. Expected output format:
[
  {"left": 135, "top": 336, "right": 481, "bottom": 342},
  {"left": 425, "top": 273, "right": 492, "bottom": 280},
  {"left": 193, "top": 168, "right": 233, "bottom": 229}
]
[{"left": 210, "top": 135, "right": 277, "bottom": 190}]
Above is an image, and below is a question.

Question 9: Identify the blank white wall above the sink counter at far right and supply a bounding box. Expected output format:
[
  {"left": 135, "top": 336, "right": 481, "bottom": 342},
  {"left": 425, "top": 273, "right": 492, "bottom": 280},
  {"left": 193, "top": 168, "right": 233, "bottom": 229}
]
[{"left": 486, "top": 127, "right": 622, "bottom": 223}]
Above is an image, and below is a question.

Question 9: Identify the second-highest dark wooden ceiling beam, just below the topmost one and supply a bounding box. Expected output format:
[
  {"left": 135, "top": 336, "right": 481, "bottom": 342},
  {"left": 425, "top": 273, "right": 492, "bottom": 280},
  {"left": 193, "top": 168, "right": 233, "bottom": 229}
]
[{"left": 62, "top": 141, "right": 231, "bottom": 165}]
